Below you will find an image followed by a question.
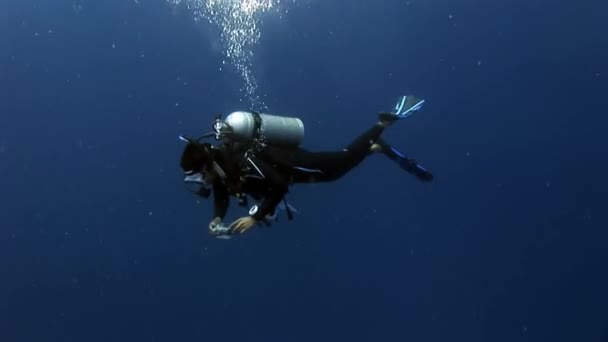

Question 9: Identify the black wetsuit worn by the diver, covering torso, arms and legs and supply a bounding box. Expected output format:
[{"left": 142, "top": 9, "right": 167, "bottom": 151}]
[{"left": 213, "top": 124, "right": 384, "bottom": 220}]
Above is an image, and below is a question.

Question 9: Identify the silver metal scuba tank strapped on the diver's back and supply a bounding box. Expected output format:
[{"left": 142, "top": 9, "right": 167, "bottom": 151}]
[{"left": 218, "top": 111, "right": 304, "bottom": 147}]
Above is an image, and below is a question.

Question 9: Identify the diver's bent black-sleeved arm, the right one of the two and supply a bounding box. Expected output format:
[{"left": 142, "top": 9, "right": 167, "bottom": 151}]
[{"left": 251, "top": 159, "right": 289, "bottom": 221}]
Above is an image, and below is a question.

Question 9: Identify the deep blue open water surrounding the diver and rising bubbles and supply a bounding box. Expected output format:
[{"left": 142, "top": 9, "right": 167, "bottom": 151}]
[{"left": 0, "top": 0, "right": 608, "bottom": 342}]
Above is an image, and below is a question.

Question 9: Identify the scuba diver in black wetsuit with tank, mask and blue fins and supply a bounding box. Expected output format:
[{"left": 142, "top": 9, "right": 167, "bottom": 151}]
[{"left": 180, "top": 96, "right": 433, "bottom": 238}]
